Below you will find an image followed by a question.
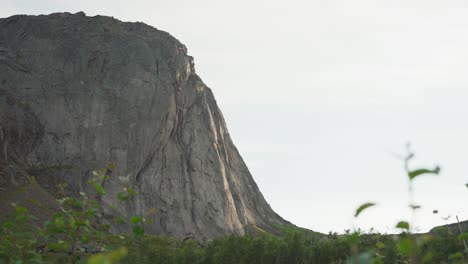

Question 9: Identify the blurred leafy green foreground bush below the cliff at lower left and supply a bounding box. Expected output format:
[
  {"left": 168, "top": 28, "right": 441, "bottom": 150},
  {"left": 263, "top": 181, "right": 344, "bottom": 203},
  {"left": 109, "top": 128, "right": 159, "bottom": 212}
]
[{"left": 0, "top": 164, "right": 144, "bottom": 264}]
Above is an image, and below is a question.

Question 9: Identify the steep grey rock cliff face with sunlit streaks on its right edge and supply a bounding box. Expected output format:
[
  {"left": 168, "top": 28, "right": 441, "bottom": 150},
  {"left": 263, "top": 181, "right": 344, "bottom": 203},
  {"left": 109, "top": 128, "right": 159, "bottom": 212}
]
[{"left": 0, "top": 13, "right": 287, "bottom": 238}]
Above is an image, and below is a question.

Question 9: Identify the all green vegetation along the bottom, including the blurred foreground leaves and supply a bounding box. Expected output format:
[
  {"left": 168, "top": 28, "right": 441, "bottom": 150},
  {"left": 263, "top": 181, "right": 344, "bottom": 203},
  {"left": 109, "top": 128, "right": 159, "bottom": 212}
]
[{"left": 0, "top": 147, "right": 468, "bottom": 264}]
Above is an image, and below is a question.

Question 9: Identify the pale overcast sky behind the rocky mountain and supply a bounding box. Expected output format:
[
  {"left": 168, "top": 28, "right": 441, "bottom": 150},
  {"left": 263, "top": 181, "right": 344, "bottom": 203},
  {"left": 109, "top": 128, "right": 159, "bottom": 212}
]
[{"left": 0, "top": 0, "right": 468, "bottom": 232}]
